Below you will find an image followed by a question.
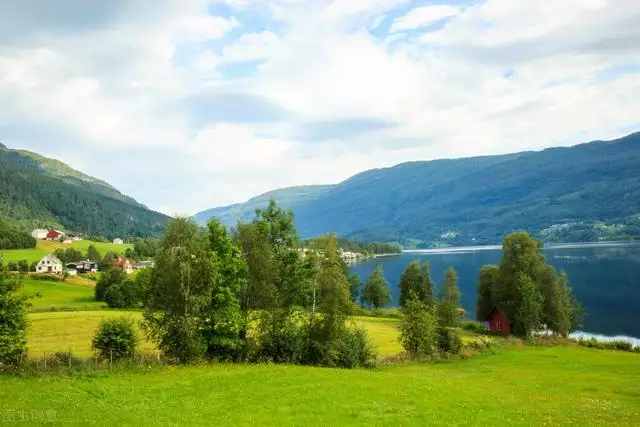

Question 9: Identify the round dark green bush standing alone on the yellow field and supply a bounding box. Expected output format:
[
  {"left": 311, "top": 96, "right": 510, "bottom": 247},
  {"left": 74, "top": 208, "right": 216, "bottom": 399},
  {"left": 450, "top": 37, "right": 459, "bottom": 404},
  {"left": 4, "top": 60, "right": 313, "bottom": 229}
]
[{"left": 93, "top": 317, "right": 138, "bottom": 360}]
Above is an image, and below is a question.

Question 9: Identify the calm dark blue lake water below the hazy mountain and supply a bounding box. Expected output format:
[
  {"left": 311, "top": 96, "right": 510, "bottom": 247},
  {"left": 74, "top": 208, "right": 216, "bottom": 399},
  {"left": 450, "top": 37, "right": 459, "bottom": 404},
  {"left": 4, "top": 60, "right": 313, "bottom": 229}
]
[{"left": 351, "top": 243, "right": 640, "bottom": 337}]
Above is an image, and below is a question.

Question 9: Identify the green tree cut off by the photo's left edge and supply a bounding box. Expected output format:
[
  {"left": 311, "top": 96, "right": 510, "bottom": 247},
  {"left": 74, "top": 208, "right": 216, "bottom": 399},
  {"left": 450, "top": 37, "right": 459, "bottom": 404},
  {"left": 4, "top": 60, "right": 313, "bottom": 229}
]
[{"left": 0, "top": 270, "right": 27, "bottom": 368}]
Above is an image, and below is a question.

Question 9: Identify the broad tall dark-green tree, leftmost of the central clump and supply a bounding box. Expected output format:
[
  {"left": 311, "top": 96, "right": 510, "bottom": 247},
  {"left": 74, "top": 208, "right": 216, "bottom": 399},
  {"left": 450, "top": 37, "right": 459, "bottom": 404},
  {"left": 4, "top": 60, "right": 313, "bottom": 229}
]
[{"left": 143, "top": 218, "right": 213, "bottom": 363}]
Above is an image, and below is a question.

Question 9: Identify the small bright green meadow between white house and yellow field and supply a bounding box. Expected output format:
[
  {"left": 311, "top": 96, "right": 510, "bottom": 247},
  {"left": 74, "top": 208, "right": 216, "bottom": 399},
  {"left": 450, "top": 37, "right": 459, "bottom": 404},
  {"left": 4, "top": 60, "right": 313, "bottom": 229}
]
[{"left": 20, "top": 277, "right": 104, "bottom": 311}]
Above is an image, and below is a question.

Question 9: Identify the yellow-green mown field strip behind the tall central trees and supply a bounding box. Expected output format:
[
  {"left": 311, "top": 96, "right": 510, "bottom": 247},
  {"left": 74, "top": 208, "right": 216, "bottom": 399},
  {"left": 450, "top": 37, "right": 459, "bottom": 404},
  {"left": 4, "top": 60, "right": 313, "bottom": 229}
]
[{"left": 27, "top": 312, "right": 402, "bottom": 359}]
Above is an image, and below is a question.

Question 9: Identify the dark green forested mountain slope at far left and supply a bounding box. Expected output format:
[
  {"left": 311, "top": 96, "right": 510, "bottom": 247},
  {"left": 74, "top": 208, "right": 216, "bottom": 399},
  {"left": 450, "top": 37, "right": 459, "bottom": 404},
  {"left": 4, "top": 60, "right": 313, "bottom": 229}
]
[{"left": 0, "top": 144, "right": 169, "bottom": 238}]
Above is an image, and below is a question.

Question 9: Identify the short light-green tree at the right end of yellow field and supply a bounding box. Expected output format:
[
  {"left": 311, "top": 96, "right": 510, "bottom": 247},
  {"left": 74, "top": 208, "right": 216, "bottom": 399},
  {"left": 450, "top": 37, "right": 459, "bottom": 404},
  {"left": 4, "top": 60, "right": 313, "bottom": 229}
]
[{"left": 399, "top": 292, "right": 438, "bottom": 359}]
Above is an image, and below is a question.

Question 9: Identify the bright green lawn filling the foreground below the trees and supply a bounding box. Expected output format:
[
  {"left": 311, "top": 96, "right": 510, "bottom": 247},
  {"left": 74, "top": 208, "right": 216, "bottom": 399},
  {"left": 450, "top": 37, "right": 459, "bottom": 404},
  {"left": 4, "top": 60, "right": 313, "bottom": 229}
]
[{"left": 0, "top": 347, "right": 640, "bottom": 426}]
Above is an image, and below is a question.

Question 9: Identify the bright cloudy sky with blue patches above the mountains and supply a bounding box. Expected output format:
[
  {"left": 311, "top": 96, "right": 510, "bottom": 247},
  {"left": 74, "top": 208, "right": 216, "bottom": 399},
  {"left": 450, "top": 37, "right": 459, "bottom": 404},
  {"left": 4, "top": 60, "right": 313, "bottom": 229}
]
[{"left": 0, "top": 0, "right": 640, "bottom": 215}]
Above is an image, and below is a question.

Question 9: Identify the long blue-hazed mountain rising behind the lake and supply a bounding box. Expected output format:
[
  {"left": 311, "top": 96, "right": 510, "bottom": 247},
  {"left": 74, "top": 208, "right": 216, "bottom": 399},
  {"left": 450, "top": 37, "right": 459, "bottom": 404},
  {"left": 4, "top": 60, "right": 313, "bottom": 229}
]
[{"left": 198, "top": 133, "right": 640, "bottom": 247}]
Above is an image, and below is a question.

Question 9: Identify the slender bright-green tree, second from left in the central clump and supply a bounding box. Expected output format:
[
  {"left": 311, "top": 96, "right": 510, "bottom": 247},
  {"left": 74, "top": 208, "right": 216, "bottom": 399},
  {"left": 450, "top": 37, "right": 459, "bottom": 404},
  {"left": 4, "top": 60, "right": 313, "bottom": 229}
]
[{"left": 204, "top": 219, "right": 247, "bottom": 360}]
